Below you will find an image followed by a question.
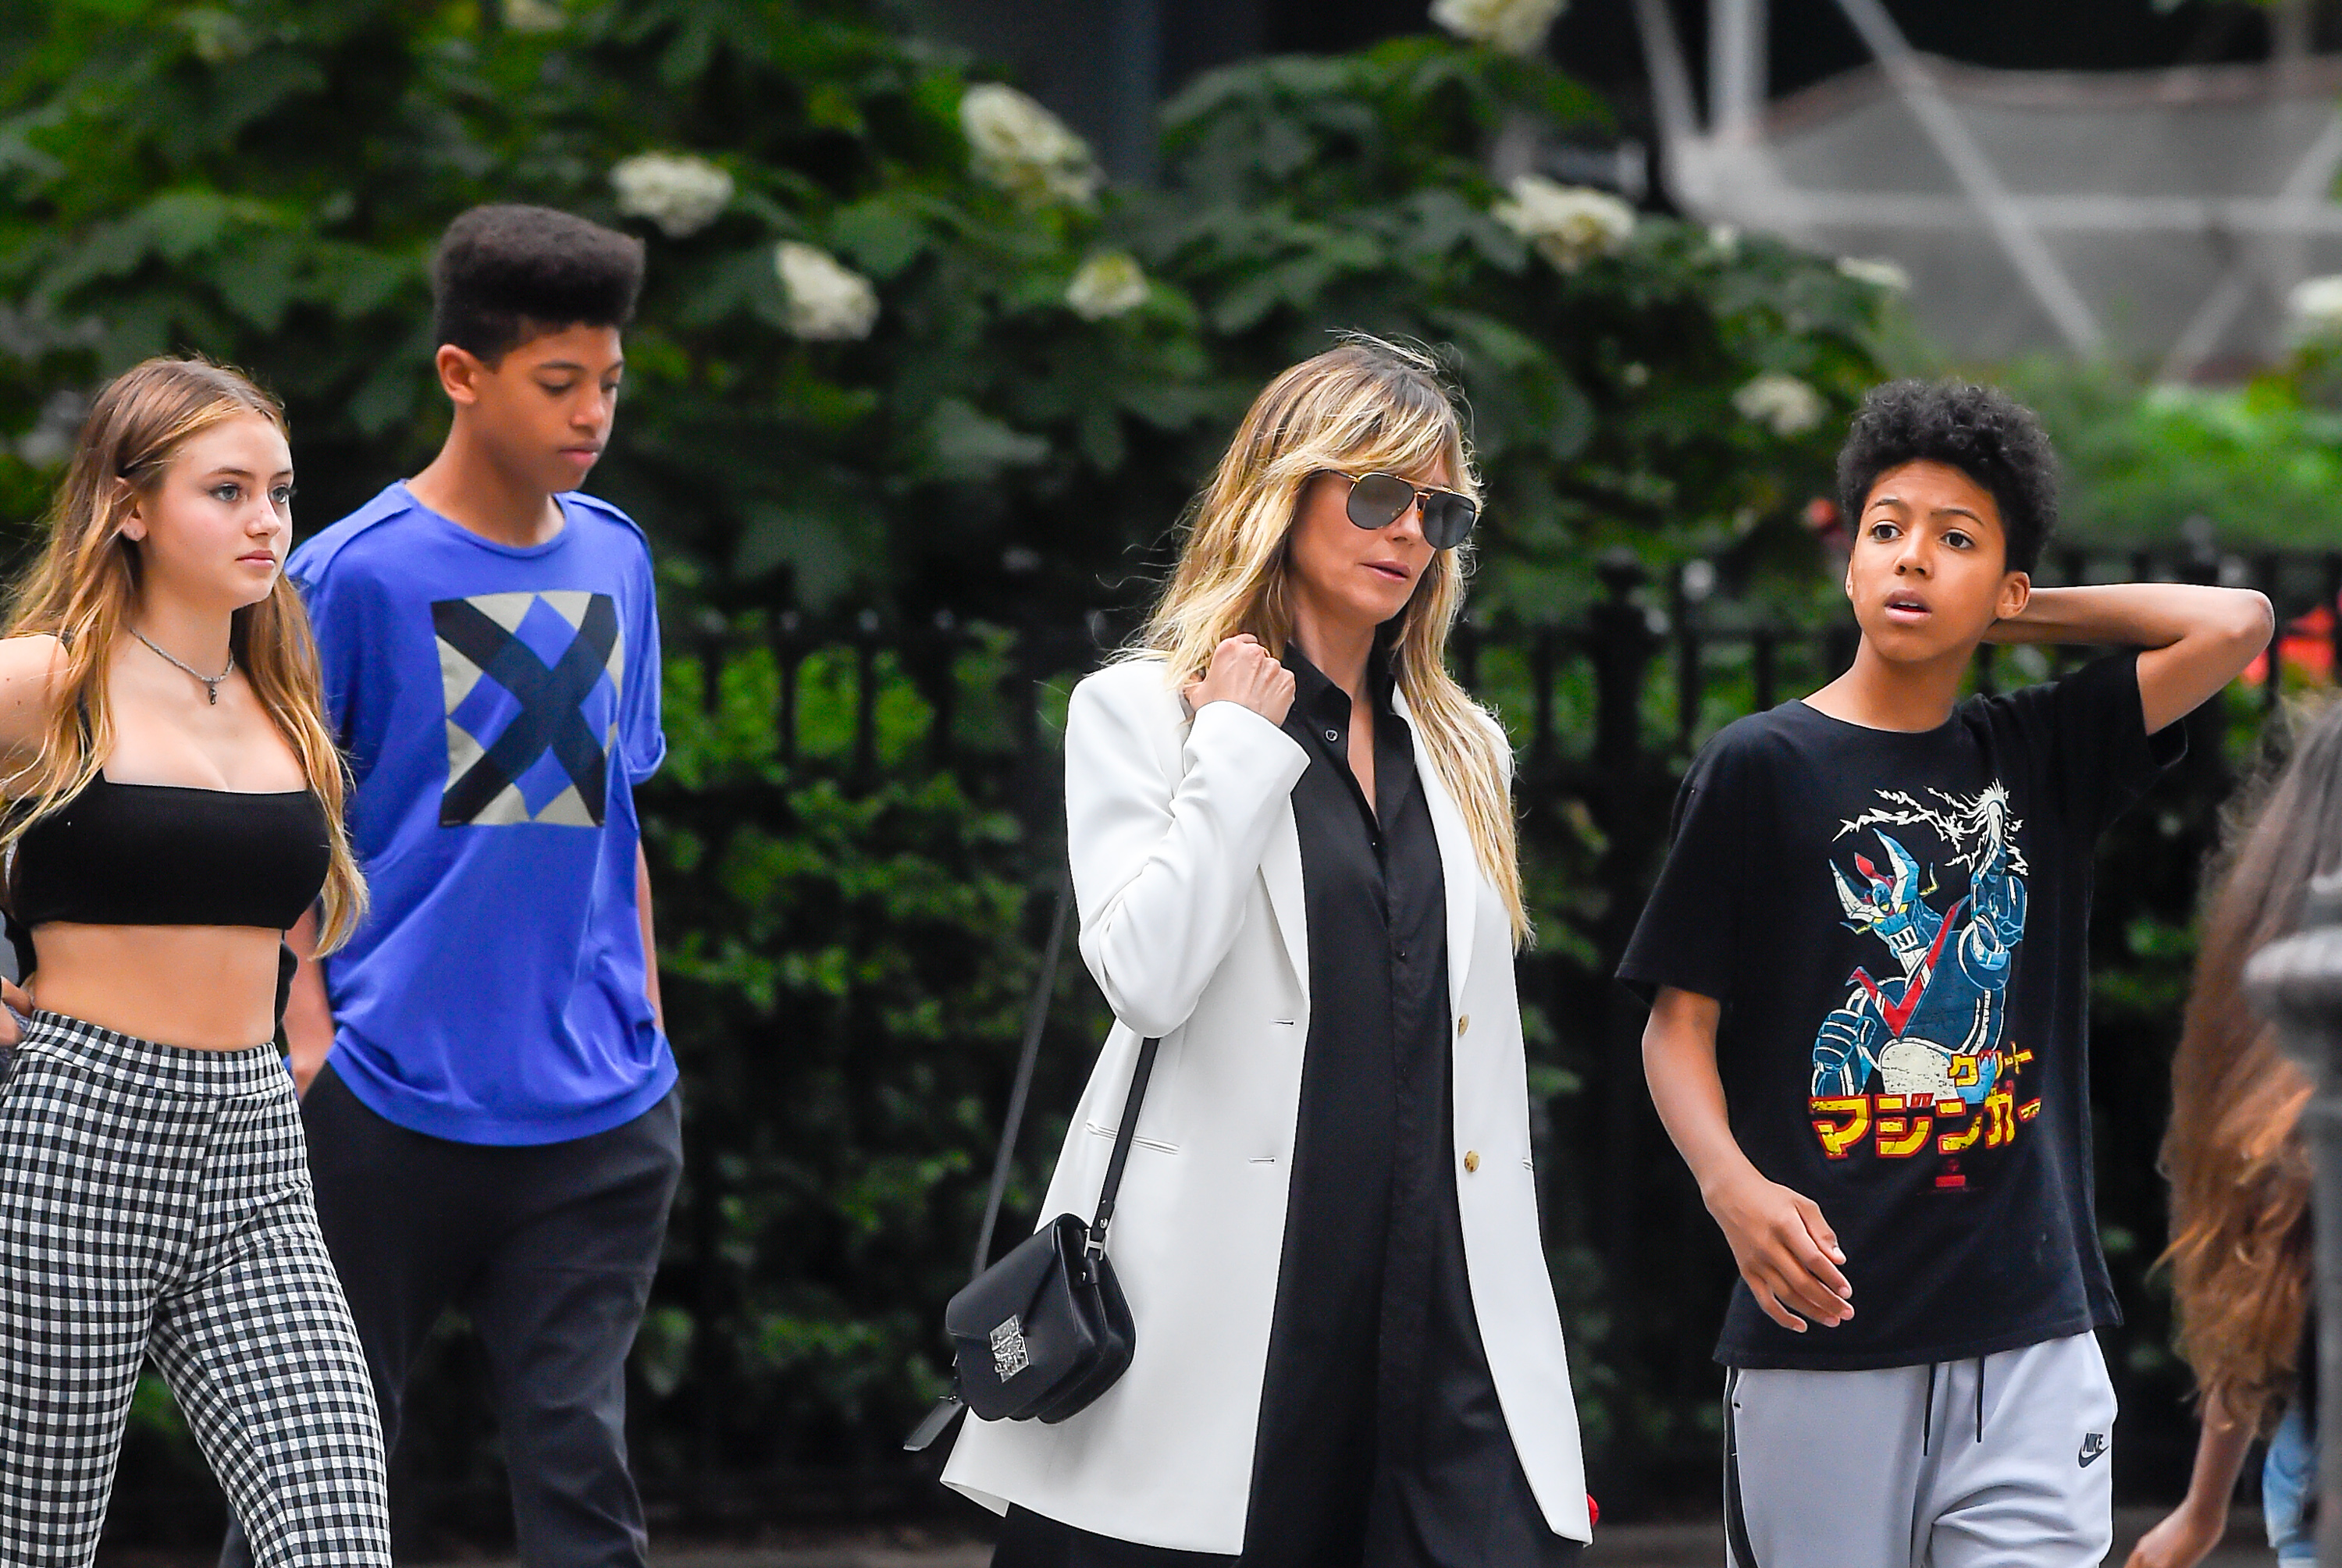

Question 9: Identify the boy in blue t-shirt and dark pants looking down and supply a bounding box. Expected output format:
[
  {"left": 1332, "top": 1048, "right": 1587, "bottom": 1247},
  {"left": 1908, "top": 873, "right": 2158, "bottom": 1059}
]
[{"left": 225, "top": 206, "right": 682, "bottom": 1568}]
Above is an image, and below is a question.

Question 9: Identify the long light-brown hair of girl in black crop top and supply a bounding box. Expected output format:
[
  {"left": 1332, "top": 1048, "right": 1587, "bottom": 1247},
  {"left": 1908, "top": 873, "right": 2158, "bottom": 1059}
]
[{"left": 0, "top": 358, "right": 365, "bottom": 952}]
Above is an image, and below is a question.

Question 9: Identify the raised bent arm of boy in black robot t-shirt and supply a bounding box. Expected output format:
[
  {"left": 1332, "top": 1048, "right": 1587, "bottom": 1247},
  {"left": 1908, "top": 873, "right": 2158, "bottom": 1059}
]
[{"left": 1984, "top": 583, "right": 2276, "bottom": 735}]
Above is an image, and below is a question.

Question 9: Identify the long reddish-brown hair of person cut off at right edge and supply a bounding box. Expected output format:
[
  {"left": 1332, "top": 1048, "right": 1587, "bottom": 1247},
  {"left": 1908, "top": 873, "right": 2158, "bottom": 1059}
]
[{"left": 2162, "top": 702, "right": 2342, "bottom": 1430}]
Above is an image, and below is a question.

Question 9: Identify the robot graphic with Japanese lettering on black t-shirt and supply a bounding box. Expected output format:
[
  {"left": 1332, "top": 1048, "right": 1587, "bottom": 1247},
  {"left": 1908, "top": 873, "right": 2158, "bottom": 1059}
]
[{"left": 1810, "top": 782, "right": 2040, "bottom": 1189}]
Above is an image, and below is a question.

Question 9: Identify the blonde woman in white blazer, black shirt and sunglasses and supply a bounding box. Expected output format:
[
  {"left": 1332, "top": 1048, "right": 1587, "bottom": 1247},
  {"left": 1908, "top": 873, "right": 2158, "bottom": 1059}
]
[{"left": 944, "top": 340, "right": 1590, "bottom": 1568}]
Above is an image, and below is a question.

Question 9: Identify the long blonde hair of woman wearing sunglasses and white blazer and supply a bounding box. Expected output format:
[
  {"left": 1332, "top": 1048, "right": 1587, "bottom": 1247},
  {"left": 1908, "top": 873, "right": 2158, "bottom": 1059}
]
[{"left": 1134, "top": 335, "right": 1529, "bottom": 940}]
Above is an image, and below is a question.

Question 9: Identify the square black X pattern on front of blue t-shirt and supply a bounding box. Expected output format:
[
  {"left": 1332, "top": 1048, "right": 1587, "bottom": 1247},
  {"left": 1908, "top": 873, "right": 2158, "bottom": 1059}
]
[{"left": 431, "top": 590, "right": 625, "bottom": 828}]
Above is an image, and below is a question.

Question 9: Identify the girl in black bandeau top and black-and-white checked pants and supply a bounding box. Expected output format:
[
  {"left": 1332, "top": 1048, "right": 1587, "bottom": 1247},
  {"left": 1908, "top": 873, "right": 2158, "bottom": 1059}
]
[{"left": 0, "top": 361, "right": 391, "bottom": 1568}]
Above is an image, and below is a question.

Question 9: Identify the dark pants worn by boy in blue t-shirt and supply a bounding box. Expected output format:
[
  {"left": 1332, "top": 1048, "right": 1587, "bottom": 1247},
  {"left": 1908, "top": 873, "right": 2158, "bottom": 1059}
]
[{"left": 220, "top": 1065, "right": 684, "bottom": 1568}]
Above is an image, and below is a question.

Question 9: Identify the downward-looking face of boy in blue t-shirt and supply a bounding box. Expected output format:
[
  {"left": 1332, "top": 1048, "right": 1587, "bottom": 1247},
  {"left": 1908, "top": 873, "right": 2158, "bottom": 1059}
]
[{"left": 438, "top": 325, "right": 625, "bottom": 496}]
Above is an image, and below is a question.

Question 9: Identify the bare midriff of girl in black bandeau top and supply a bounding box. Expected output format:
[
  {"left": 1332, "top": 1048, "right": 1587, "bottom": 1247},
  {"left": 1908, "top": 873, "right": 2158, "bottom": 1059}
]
[{"left": 26, "top": 922, "right": 279, "bottom": 1051}]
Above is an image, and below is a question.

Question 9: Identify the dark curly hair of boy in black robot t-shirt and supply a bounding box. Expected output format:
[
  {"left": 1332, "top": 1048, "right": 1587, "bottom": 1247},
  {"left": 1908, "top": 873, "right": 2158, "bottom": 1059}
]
[{"left": 1838, "top": 382, "right": 2059, "bottom": 571}]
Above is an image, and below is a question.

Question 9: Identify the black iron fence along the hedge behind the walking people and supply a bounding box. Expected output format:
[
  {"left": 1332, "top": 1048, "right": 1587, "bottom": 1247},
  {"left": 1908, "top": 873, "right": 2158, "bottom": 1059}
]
[{"left": 206, "top": 550, "right": 2342, "bottom": 1531}]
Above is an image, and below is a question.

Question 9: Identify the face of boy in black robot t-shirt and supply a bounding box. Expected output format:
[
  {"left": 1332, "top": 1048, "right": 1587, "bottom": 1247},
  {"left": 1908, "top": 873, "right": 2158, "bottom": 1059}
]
[{"left": 1845, "top": 459, "right": 2033, "bottom": 665}]
